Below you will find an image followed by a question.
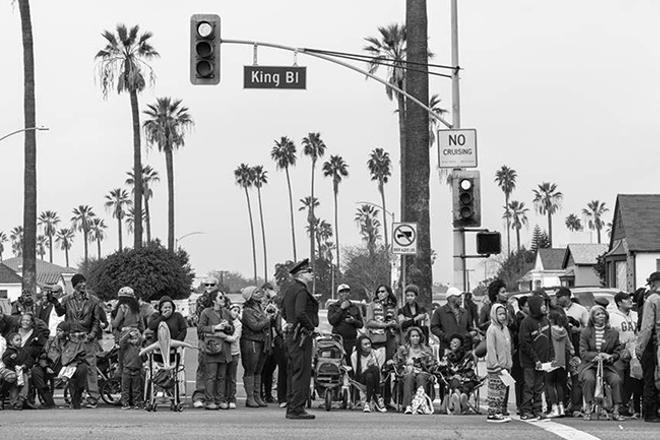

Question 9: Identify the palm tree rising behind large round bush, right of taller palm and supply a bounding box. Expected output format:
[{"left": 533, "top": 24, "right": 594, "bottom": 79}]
[{"left": 144, "top": 97, "right": 194, "bottom": 251}]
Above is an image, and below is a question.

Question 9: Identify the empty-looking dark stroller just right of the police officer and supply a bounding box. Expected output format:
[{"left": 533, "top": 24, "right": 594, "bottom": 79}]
[{"left": 308, "top": 334, "right": 350, "bottom": 411}]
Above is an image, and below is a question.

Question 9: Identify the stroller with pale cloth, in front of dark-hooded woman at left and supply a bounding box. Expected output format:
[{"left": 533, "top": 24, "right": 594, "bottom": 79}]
[{"left": 140, "top": 322, "right": 194, "bottom": 412}]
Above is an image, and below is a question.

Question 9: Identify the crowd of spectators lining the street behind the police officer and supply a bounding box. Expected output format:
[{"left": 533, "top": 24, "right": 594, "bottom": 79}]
[{"left": 0, "top": 272, "right": 660, "bottom": 423}]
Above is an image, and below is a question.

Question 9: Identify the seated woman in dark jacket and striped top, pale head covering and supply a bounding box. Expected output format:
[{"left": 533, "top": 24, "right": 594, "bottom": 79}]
[{"left": 578, "top": 305, "right": 624, "bottom": 421}]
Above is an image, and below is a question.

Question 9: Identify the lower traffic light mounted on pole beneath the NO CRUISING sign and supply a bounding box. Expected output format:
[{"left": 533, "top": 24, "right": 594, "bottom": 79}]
[{"left": 452, "top": 170, "right": 481, "bottom": 228}]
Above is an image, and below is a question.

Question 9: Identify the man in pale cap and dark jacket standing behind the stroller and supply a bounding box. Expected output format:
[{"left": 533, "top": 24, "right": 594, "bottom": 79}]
[{"left": 328, "top": 284, "right": 364, "bottom": 365}]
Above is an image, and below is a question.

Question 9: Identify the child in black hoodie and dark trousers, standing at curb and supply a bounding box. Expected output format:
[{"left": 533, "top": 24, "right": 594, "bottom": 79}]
[{"left": 518, "top": 293, "right": 554, "bottom": 421}]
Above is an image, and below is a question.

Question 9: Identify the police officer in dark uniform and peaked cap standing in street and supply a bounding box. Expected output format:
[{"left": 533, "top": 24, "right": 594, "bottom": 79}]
[{"left": 282, "top": 259, "right": 319, "bottom": 419}]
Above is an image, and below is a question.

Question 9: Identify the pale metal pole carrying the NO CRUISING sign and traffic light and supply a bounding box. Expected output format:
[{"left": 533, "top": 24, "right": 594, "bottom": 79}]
[{"left": 450, "top": 0, "right": 469, "bottom": 291}]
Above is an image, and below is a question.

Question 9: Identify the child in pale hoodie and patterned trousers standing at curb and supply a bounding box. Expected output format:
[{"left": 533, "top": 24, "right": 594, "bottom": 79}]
[{"left": 486, "top": 303, "right": 513, "bottom": 423}]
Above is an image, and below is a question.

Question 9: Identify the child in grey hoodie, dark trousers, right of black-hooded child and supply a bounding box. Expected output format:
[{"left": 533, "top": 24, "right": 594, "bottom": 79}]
[{"left": 546, "top": 312, "right": 575, "bottom": 419}]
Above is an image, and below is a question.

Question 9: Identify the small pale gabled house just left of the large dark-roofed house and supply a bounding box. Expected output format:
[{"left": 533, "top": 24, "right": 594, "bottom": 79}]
[{"left": 560, "top": 243, "right": 609, "bottom": 287}]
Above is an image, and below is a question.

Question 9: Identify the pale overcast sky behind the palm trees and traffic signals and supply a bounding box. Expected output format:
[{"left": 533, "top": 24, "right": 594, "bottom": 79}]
[{"left": 0, "top": 0, "right": 660, "bottom": 283}]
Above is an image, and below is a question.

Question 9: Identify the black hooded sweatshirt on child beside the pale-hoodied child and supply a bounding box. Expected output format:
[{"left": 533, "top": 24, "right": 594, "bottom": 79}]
[{"left": 518, "top": 295, "right": 554, "bottom": 368}]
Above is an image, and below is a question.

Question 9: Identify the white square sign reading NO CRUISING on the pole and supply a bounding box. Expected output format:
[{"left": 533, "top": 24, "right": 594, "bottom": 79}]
[{"left": 438, "top": 128, "right": 477, "bottom": 168}]
